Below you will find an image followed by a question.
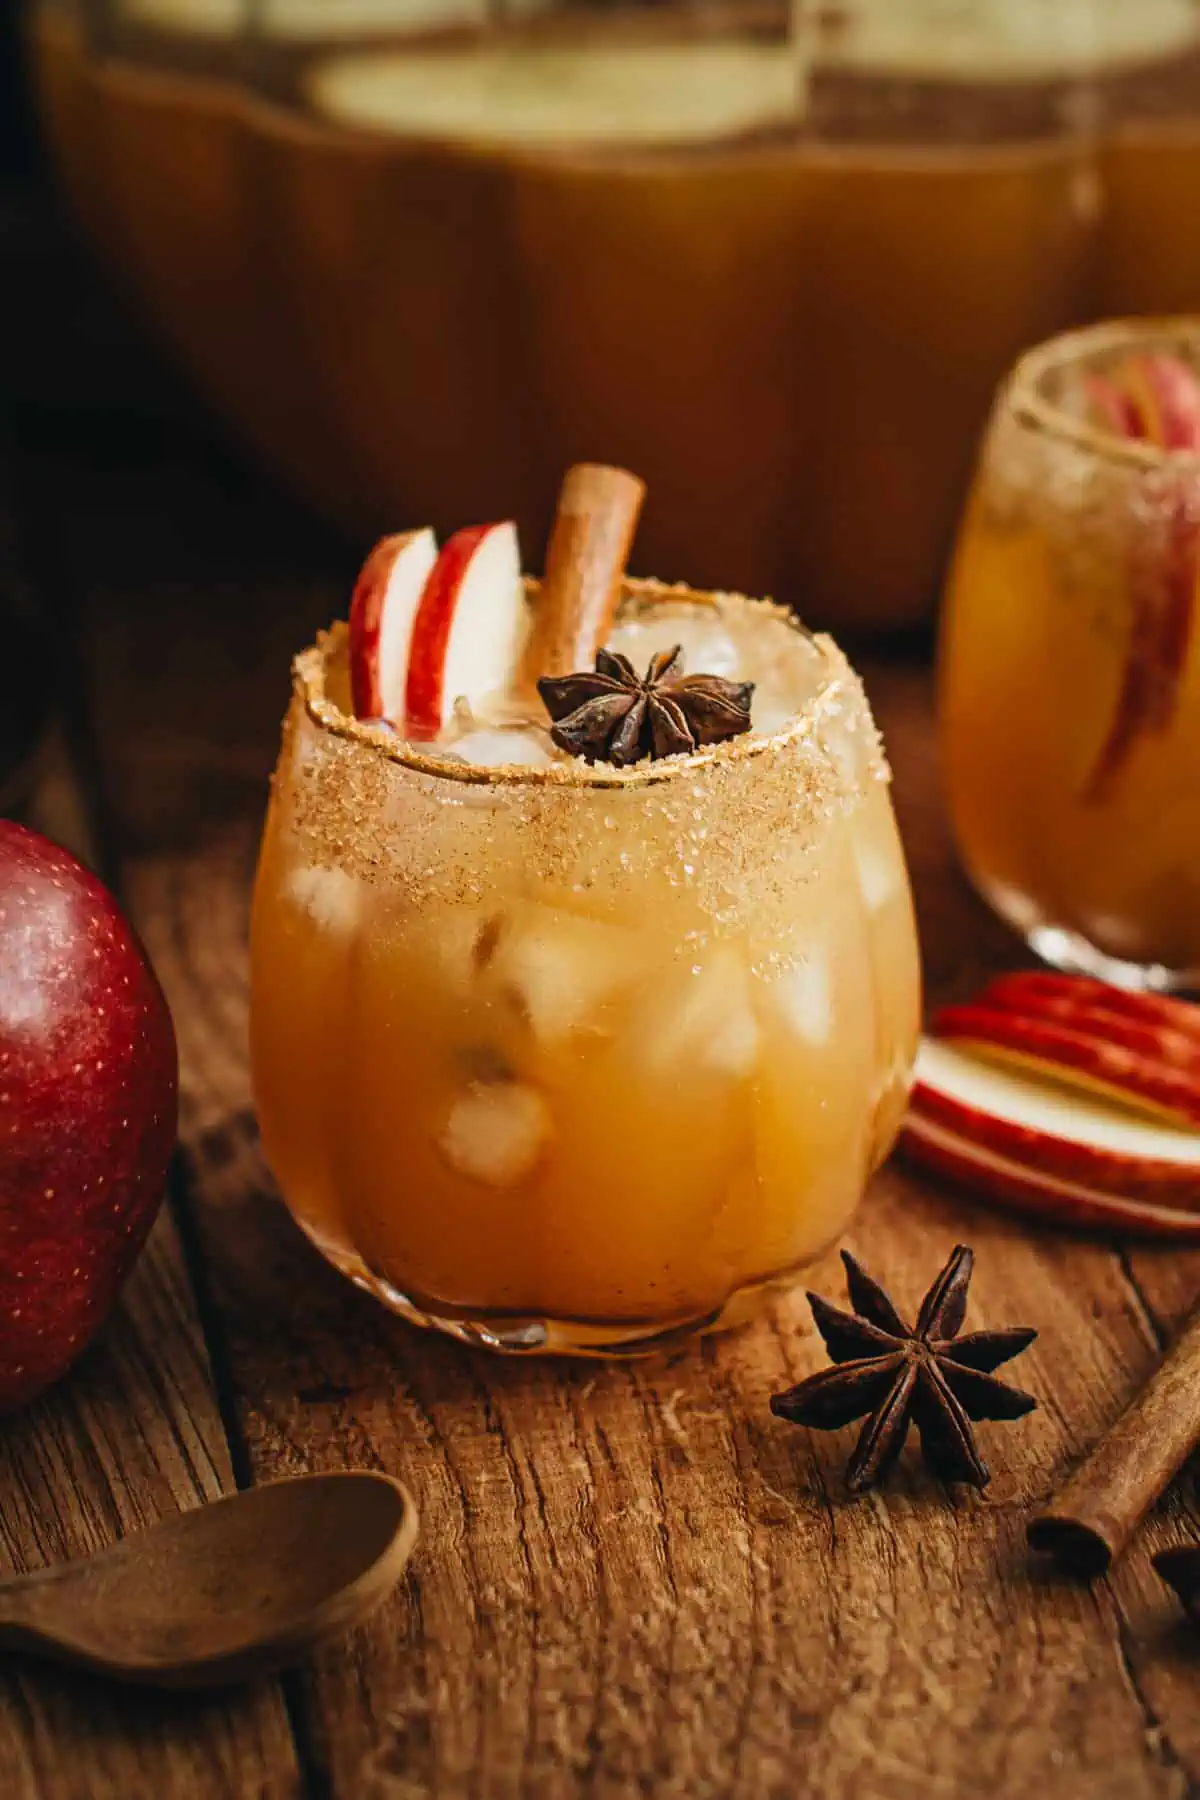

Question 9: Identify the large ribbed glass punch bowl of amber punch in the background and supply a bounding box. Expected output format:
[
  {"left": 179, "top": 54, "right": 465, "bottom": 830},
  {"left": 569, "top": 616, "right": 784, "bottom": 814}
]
[{"left": 31, "top": 0, "right": 1200, "bottom": 630}]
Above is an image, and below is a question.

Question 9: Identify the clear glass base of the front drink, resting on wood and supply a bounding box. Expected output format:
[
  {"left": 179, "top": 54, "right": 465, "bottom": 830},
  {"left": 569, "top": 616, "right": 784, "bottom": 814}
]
[{"left": 300, "top": 1226, "right": 813, "bottom": 1357}]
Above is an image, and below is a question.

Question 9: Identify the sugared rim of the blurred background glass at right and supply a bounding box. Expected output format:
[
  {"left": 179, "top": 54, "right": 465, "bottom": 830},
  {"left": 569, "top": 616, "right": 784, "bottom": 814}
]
[{"left": 999, "top": 313, "right": 1200, "bottom": 470}]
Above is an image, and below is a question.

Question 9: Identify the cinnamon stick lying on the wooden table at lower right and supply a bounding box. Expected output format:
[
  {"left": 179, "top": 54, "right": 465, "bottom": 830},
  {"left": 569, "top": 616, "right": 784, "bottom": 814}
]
[{"left": 1025, "top": 1305, "right": 1200, "bottom": 1575}]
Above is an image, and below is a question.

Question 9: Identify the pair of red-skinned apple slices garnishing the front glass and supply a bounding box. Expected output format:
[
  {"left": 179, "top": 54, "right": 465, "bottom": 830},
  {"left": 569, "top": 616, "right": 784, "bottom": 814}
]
[{"left": 349, "top": 520, "right": 527, "bottom": 740}]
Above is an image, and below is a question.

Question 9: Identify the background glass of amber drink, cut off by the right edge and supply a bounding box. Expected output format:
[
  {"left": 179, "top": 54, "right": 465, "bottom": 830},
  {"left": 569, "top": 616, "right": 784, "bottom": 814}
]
[{"left": 941, "top": 320, "right": 1200, "bottom": 986}]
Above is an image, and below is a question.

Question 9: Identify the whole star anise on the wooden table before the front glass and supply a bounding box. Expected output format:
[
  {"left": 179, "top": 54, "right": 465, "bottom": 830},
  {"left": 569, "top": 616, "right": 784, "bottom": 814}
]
[{"left": 770, "top": 1244, "right": 1038, "bottom": 1494}]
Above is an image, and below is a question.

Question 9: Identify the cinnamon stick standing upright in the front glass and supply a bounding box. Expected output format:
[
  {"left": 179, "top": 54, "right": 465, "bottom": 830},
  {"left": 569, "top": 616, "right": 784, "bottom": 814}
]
[{"left": 520, "top": 463, "right": 646, "bottom": 689}]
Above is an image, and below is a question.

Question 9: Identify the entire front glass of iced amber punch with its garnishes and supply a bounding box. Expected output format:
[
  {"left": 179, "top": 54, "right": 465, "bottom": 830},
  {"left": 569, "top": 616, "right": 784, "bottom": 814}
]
[{"left": 241, "top": 464, "right": 919, "bottom": 1354}]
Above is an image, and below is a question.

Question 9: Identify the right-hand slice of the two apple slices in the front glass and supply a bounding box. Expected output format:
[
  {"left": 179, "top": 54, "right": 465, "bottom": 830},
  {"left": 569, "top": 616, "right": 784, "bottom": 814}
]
[{"left": 405, "top": 522, "right": 527, "bottom": 738}]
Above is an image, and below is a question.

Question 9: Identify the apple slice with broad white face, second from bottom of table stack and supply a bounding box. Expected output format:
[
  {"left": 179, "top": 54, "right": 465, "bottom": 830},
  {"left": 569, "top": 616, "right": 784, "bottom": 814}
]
[{"left": 912, "top": 1039, "right": 1200, "bottom": 1213}]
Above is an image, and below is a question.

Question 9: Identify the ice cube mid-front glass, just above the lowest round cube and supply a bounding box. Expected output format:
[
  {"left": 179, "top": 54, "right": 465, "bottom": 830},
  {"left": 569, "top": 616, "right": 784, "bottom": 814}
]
[{"left": 489, "top": 902, "right": 639, "bottom": 1046}]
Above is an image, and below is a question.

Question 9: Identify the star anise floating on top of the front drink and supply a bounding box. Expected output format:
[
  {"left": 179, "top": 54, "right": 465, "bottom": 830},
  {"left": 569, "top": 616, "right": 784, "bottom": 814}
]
[{"left": 538, "top": 644, "right": 754, "bottom": 769}]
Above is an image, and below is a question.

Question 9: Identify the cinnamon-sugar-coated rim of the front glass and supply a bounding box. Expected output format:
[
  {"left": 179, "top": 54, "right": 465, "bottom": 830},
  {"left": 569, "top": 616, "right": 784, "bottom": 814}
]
[{"left": 291, "top": 576, "right": 849, "bottom": 788}]
